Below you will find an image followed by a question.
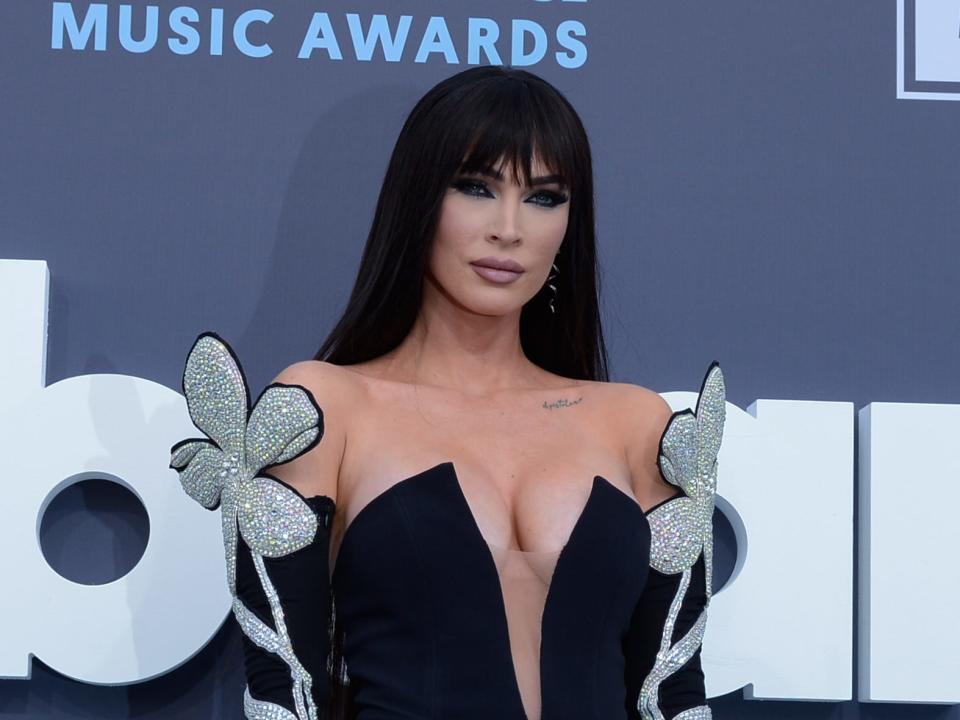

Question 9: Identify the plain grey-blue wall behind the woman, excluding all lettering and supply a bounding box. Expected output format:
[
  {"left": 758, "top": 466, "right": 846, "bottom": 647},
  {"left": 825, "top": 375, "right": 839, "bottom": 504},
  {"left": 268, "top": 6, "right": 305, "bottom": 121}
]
[{"left": 0, "top": 0, "right": 960, "bottom": 720}]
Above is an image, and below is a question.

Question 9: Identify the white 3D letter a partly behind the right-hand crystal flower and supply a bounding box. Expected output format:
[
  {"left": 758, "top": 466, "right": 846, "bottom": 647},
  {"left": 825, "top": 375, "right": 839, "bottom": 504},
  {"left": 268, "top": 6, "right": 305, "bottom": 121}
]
[{"left": 664, "top": 390, "right": 853, "bottom": 700}]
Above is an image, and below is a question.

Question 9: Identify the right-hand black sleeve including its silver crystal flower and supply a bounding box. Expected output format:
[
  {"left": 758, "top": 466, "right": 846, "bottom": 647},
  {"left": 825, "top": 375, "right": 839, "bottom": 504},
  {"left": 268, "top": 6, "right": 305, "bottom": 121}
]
[{"left": 623, "top": 361, "right": 726, "bottom": 720}]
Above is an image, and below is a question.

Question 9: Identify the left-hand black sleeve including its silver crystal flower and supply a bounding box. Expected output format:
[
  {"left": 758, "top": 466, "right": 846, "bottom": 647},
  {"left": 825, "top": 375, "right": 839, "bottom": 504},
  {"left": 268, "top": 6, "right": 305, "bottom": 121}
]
[{"left": 170, "top": 332, "right": 336, "bottom": 720}]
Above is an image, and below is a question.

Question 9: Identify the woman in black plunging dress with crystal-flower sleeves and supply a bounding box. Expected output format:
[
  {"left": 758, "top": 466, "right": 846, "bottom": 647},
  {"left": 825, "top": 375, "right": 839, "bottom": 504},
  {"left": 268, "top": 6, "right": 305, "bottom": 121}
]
[{"left": 171, "top": 66, "right": 724, "bottom": 720}]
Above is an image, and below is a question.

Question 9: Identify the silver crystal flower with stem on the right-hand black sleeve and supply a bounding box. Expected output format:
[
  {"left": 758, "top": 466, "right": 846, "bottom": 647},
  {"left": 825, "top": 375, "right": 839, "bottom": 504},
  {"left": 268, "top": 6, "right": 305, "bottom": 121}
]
[{"left": 637, "top": 361, "right": 726, "bottom": 720}]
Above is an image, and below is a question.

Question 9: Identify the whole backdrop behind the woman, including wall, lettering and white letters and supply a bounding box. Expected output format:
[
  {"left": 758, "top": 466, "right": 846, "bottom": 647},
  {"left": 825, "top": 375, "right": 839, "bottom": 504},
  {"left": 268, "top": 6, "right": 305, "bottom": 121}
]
[{"left": 0, "top": 0, "right": 960, "bottom": 720}]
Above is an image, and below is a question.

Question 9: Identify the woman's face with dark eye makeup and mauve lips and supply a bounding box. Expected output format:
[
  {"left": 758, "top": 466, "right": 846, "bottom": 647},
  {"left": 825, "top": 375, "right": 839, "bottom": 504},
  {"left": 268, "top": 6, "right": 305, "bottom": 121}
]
[{"left": 427, "top": 159, "right": 570, "bottom": 315}]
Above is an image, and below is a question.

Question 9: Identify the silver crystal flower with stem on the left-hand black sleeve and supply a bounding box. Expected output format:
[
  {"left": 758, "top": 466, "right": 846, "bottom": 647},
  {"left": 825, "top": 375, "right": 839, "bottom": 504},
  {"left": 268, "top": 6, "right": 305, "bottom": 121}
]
[{"left": 170, "top": 332, "right": 323, "bottom": 720}]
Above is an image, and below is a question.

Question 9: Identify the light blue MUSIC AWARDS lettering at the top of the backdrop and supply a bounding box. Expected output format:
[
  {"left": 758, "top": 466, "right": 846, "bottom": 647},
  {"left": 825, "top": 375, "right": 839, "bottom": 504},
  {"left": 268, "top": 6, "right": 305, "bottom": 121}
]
[{"left": 50, "top": 0, "right": 587, "bottom": 69}]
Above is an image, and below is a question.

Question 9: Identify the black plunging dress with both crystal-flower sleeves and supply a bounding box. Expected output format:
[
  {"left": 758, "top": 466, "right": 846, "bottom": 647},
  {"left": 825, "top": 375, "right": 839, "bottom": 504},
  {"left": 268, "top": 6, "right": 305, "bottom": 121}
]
[{"left": 170, "top": 333, "right": 725, "bottom": 720}]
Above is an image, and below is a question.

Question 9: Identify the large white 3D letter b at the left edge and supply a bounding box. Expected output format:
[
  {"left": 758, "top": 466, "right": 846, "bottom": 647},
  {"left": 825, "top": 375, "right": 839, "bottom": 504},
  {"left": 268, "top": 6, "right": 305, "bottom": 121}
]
[{"left": 0, "top": 260, "right": 230, "bottom": 684}]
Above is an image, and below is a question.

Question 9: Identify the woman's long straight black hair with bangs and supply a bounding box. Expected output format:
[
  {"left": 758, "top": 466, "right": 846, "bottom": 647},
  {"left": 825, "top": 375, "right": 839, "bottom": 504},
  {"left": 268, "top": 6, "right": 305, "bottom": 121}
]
[{"left": 314, "top": 65, "right": 608, "bottom": 381}]
